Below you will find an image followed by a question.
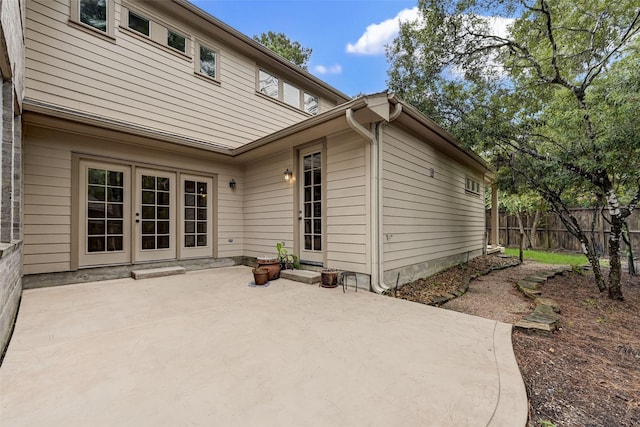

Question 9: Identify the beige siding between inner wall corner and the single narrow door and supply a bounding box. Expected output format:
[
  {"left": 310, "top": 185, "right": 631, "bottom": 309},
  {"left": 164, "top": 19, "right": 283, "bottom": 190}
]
[{"left": 243, "top": 150, "right": 297, "bottom": 257}]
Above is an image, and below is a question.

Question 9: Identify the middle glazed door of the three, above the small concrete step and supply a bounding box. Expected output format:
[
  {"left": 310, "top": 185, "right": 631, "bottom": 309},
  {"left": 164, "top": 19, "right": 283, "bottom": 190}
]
[{"left": 134, "top": 169, "right": 176, "bottom": 262}]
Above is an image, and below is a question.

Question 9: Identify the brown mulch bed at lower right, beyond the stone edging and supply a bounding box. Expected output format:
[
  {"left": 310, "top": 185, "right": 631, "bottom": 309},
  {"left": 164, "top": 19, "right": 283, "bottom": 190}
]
[{"left": 513, "top": 273, "right": 640, "bottom": 427}]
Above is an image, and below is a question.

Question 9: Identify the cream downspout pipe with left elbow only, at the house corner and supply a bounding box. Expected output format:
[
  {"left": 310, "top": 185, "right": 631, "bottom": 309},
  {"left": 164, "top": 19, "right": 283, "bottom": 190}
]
[{"left": 345, "top": 108, "right": 389, "bottom": 294}]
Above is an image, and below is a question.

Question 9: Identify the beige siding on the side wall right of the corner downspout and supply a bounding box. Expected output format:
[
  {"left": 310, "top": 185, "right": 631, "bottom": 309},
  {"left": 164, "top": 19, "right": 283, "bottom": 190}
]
[{"left": 382, "top": 126, "right": 485, "bottom": 271}]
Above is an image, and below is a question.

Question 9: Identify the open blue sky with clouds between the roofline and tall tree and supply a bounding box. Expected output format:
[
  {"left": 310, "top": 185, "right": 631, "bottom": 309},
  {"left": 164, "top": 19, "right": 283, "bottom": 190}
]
[{"left": 191, "top": 0, "right": 417, "bottom": 96}]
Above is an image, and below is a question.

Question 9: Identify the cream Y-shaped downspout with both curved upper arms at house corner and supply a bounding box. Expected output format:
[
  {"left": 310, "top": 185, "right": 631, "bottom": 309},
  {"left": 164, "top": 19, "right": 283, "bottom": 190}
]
[{"left": 345, "top": 102, "right": 402, "bottom": 294}]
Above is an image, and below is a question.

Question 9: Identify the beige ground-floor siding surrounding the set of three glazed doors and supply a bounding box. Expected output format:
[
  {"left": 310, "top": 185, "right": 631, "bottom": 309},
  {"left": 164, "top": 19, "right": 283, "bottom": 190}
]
[{"left": 24, "top": 126, "right": 243, "bottom": 274}]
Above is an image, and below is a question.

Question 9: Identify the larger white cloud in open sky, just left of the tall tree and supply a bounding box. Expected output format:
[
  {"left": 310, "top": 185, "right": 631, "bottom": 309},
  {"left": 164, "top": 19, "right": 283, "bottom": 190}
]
[{"left": 347, "top": 7, "right": 419, "bottom": 55}]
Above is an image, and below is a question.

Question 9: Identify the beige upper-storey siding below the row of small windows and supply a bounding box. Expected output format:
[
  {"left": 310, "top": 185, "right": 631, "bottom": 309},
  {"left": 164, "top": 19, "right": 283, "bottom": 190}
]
[{"left": 26, "top": 0, "right": 326, "bottom": 147}]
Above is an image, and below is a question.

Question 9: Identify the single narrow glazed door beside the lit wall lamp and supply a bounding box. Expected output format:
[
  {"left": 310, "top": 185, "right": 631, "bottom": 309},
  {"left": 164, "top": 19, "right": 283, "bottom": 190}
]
[{"left": 299, "top": 146, "right": 325, "bottom": 265}]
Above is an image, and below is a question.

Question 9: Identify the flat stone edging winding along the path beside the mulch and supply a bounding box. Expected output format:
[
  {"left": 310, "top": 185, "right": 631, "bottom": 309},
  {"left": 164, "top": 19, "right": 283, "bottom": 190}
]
[{"left": 514, "top": 267, "right": 573, "bottom": 332}]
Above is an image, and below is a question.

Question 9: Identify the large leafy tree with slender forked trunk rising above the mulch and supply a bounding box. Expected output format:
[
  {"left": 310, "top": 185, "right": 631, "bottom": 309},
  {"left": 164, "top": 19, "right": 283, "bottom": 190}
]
[{"left": 387, "top": 0, "right": 640, "bottom": 299}]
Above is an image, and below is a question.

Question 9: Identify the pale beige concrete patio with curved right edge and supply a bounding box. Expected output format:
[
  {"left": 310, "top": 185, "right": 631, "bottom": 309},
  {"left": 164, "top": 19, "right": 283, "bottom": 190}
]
[{"left": 0, "top": 266, "right": 527, "bottom": 427}]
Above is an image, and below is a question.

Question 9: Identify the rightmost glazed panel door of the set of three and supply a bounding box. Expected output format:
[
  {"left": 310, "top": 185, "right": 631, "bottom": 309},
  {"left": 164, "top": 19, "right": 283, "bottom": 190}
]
[{"left": 180, "top": 175, "right": 213, "bottom": 258}]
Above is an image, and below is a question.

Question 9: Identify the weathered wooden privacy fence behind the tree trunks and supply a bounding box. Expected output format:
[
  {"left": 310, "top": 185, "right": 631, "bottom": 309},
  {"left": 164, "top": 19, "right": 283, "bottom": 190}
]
[{"left": 486, "top": 208, "right": 640, "bottom": 257}]
